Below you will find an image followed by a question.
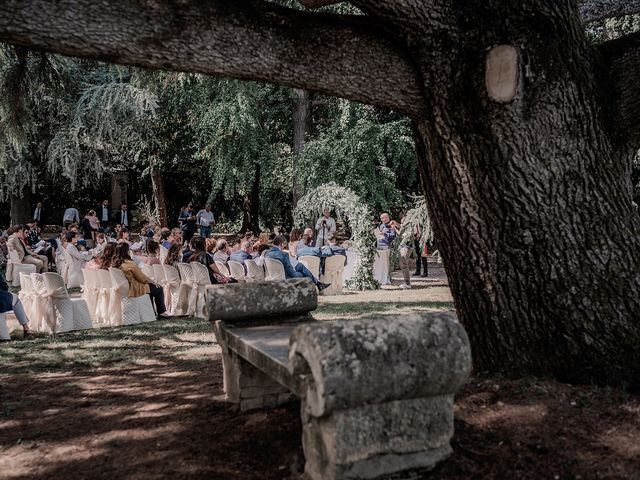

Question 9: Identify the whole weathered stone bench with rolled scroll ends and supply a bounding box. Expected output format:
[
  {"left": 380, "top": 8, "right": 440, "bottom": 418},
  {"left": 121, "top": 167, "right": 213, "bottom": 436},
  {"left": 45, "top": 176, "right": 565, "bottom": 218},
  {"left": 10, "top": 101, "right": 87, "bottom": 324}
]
[{"left": 208, "top": 279, "right": 471, "bottom": 480}]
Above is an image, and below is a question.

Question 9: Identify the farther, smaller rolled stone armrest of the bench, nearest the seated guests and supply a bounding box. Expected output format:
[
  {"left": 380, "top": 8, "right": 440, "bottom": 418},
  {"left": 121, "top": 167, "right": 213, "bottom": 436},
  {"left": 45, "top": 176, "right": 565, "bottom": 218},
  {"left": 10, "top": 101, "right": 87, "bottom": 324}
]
[{"left": 207, "top": 278, "right": 318, "bottom": 323}]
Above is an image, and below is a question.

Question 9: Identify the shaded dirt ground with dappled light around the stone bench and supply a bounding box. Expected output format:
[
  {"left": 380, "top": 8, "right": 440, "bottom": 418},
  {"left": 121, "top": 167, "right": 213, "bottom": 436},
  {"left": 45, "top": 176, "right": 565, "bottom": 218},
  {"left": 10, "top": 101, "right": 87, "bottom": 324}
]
[{"left": 0, "top": 264, "right": 640, "bottom": 480}]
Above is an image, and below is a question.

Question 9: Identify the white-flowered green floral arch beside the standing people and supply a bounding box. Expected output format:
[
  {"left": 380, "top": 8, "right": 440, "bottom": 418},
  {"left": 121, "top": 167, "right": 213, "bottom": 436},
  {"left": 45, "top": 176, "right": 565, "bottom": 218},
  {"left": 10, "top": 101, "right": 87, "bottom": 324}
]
[{"left": 293, "top": 182, "right": 380, "bottom": 290}]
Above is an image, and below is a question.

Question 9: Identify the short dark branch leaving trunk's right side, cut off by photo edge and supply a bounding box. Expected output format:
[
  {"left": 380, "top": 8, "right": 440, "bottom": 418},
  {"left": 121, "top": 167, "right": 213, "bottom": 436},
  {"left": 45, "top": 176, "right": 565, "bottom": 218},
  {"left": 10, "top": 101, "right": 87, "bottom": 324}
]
[{"left": 599, "top": 32, "right": 640, "bottom": 143}]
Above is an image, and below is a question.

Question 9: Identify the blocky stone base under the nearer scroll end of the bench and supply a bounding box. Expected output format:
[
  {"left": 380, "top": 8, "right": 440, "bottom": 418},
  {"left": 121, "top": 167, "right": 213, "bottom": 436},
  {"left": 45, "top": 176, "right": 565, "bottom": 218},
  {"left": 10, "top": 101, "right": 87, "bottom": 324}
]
[{"left": 302, "top": 395, "right": 453, "bottom": 480}]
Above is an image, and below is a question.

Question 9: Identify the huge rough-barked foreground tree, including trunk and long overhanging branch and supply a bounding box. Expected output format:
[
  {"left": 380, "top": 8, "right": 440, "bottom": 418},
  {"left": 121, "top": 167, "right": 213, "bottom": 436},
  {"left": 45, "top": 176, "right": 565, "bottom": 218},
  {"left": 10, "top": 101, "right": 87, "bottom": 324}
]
[{"left": 0, "top": 0, "right": 640, "bottom": 387}]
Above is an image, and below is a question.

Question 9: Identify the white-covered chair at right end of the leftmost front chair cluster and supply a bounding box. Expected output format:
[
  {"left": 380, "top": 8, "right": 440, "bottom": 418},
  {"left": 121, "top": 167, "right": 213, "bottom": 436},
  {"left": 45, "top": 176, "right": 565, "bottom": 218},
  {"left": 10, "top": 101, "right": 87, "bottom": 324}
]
[{"left": 42, "top": 272, "right": 93, "bottom": 333}]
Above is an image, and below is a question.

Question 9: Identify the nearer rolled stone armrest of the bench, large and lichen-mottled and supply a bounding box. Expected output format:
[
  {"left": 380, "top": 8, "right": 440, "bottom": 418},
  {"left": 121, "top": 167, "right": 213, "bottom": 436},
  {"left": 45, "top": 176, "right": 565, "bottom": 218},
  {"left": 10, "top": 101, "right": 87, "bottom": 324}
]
[{"left": 289, "top": 312, "right": 471, "bottom": 417}]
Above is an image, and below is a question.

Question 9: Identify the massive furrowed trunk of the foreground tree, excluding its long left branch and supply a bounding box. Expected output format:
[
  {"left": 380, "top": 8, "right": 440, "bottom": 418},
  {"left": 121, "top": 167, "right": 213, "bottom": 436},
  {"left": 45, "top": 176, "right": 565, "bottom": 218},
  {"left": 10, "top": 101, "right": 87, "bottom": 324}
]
[{"left": 415, "top": 0, "right": 640, "bottom": 387}]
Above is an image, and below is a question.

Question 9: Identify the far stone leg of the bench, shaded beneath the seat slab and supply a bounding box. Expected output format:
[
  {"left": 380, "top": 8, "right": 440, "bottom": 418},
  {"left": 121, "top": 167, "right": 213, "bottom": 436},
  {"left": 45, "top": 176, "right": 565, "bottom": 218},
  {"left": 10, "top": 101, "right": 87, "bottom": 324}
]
[{"left": 222, "top": 349, "right": 295, "bottom": 411}]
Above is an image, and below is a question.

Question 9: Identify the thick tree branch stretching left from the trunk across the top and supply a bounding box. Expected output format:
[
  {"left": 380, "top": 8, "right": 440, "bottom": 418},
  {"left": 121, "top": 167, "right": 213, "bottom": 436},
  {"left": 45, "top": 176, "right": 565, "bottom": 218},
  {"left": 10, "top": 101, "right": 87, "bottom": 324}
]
[{"left": 0, "top": 0, "right": 424, "bottom": 117}]
